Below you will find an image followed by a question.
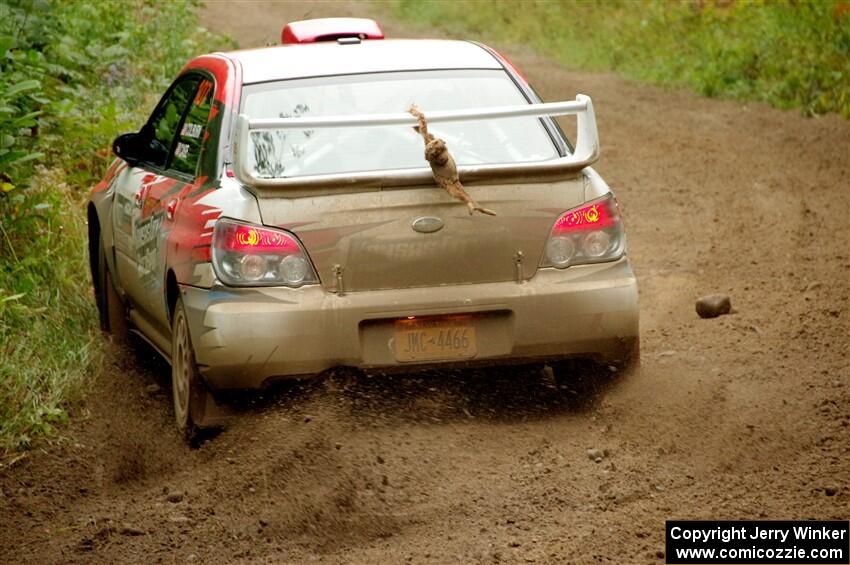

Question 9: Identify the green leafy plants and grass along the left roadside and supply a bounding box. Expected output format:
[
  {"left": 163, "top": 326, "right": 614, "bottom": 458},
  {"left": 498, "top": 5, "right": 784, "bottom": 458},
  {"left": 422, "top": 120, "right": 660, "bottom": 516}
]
[{"left": 0, "top": 0, "right": 229, "bottom": 452}]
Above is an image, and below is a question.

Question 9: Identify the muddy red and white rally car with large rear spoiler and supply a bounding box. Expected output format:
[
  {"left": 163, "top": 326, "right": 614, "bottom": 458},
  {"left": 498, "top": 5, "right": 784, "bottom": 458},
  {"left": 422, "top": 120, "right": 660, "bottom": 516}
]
[{"left": 88, "top": 18, "right": 639, "bottom": 436}]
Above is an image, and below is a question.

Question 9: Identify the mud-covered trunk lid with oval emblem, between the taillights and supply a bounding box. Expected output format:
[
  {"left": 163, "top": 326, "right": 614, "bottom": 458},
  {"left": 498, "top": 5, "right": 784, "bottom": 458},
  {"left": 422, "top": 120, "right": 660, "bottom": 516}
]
[{"left": 259, "top": 177, "right": 584, "bottom": 291}]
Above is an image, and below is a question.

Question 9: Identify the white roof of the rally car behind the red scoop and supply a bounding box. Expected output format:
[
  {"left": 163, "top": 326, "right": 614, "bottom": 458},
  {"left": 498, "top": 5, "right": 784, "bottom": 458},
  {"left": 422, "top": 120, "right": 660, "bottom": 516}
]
[{"left": 223, "top": 39, "right": 502, "bottom": 84}]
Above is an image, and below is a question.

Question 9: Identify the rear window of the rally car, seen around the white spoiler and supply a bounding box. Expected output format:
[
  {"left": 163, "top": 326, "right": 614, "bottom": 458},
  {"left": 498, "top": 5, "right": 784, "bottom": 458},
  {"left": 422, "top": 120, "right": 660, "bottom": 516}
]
[{"left": 241, "top": 70, "right": 559, "bottom": 178}]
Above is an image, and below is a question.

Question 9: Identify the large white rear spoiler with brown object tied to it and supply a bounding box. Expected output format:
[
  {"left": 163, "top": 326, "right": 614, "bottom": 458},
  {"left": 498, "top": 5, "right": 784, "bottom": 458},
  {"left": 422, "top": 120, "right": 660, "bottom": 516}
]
[{"left": 233, "top": 94, "right": 599, "bottom": 196}]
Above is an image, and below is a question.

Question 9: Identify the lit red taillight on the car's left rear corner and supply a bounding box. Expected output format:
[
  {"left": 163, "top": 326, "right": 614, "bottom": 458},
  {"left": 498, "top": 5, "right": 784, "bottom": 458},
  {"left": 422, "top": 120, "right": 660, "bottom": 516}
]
[{"left": 212, "top": 219, "right": 319, "bottom": 287}]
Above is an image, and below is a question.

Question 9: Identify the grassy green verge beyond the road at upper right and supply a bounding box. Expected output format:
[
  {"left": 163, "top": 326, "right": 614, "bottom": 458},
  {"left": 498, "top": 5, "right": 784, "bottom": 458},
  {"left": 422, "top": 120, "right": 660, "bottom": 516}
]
[{"left": 392, "top": 0, "right": 850, "bottom": 118}]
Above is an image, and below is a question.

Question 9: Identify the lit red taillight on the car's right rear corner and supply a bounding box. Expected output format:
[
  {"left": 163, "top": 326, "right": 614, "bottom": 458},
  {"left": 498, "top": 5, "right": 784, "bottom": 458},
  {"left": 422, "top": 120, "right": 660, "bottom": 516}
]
[{"left": 540, "top": 194, "right": 626, "bottom": 269}]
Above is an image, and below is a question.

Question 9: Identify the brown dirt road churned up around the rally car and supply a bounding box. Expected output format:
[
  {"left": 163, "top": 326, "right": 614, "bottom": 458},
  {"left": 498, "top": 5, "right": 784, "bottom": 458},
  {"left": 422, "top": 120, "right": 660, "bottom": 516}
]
[{"left": 0, "top": 4, "right": 850, "bottom": 563}]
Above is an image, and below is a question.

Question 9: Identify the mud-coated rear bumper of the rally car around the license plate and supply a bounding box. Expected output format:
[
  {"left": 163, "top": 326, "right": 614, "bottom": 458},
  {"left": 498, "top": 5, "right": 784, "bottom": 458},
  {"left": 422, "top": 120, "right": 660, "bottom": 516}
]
[{"left": 181, "top": 258, "right": 638, "bottom": 389}]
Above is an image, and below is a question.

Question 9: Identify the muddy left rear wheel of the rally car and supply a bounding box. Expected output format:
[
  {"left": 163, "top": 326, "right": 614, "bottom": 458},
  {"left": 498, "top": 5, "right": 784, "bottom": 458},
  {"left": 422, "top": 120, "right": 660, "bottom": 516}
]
[{"left": 171, "top": 297, "right": 212, "bottom": 445}]
